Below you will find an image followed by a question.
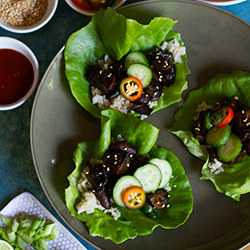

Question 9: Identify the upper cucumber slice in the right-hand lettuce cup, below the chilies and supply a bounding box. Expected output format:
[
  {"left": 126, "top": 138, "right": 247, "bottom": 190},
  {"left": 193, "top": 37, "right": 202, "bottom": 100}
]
[{"left": 206, "top": 125, "right": 231, "bottom": 147}]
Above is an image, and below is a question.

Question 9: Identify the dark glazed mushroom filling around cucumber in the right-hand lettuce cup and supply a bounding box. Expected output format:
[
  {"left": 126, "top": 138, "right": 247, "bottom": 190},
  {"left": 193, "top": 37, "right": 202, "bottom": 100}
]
[{"left": 192, "top": 98, "right": 250, "bottom": 164}]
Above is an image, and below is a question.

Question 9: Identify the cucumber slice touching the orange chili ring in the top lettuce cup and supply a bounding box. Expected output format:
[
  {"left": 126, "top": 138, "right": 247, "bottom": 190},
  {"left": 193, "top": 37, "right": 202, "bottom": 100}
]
[{"left": 127, "top": 63, "right": 152, "bottom": 88}]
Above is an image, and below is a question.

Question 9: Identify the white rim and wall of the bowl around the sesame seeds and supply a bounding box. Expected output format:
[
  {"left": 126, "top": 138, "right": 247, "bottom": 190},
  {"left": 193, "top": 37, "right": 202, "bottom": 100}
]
[{"left": 0, "top": 0, "right": 58, "bottom": 33}]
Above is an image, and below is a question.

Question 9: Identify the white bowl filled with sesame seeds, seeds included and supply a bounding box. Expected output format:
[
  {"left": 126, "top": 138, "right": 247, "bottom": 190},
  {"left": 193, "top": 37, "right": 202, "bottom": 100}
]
[{"left": 0, "top": 0, "right": 58, "bottom": 33}]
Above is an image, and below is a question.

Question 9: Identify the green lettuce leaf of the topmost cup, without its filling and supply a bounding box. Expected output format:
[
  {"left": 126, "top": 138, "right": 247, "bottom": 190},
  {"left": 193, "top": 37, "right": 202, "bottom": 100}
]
[{"left": 64, "top": 8, "right": 189, "bottom": 118}]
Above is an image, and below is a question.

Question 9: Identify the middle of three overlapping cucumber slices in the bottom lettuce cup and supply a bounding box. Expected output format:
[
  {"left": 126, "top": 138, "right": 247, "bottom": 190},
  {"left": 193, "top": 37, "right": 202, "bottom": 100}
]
[{"left": 134, "top": 163, "right": 162, "bottom": 193}]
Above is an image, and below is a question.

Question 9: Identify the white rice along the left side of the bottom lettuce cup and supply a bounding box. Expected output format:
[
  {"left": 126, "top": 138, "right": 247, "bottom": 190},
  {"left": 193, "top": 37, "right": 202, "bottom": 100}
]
[{"left": 76, "top": 168, "right": 121, "bottom": 220}]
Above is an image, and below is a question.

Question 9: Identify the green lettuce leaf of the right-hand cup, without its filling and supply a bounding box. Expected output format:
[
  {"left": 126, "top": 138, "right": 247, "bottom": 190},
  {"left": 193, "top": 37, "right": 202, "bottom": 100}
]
[{"left": 169, "top": 71, "right": 250, "bottom": 201}]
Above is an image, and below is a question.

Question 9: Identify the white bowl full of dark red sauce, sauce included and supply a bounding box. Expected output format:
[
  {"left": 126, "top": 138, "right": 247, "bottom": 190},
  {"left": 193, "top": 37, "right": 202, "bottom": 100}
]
[{"left": 0, "top": 37, "right": 39, "bottom": 111}]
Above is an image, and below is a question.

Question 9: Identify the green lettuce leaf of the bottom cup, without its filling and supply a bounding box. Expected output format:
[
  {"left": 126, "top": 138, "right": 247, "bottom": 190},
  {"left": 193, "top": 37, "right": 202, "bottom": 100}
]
[{"left": 65, "top": 110, "right": 193, "bottom": 243}]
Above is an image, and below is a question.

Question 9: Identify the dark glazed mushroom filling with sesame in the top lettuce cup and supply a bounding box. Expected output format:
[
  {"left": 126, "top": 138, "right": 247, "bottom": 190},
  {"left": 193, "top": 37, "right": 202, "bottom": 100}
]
[{"left": 86, "top": 47, "right": 176, "bottom": 116}]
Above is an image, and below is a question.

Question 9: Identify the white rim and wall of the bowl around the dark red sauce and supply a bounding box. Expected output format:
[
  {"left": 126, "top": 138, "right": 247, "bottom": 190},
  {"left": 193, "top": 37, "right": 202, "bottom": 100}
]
[{"left": 0, "top": 36, "right": 39, "bottom": 111}]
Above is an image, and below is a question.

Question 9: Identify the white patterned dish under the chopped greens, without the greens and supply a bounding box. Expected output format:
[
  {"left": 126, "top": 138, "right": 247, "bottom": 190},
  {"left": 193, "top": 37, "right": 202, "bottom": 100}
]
[{"left": 0, "top": 192, "right": 86, "bottom": 250}]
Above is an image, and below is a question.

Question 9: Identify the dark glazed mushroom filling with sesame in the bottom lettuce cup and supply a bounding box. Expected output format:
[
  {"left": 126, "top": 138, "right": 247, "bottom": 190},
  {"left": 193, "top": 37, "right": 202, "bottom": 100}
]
[{"left": 86, "top": 141, "right": 169, "bottom": 212}]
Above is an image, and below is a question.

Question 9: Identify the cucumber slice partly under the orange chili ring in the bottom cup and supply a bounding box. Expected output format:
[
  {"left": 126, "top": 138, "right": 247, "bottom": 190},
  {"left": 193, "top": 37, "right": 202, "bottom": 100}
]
[{"left": 113, "top": 175, "right": 142, "bottom": 207}]
